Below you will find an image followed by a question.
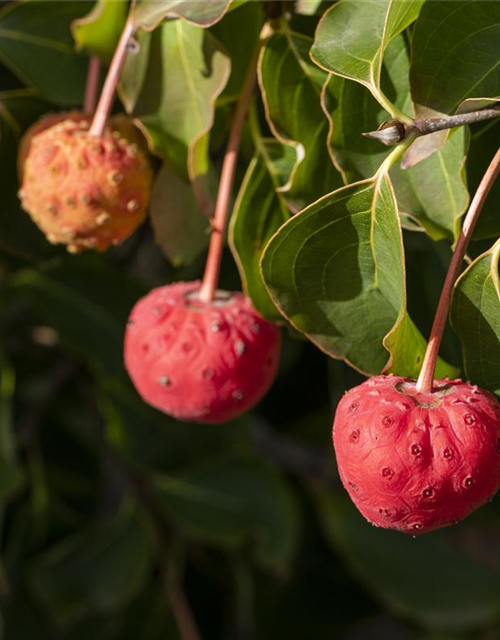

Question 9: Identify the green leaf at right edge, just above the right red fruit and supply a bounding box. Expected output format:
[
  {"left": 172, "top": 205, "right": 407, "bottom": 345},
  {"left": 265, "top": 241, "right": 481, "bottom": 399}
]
[{"left": 450, "top": 241, "right": 500, "bottom": 394}]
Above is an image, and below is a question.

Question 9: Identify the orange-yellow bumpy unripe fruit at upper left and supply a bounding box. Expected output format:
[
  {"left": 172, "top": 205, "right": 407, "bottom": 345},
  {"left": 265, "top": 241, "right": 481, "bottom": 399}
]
[{"left": 19, "top": 114, "right": 152, "bottom": 253}]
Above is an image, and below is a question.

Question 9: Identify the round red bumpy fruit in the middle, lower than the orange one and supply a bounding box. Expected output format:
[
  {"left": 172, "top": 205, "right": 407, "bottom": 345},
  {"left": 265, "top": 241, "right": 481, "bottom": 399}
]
[{"left": 124, "top": 282, "right": 281, "bottom": 423}]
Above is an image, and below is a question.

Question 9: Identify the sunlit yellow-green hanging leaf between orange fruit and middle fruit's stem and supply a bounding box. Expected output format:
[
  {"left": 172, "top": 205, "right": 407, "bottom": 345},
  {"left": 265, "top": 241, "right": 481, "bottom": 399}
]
[{"left": 121, "top": 20, "right": 231, "bottom": 183}]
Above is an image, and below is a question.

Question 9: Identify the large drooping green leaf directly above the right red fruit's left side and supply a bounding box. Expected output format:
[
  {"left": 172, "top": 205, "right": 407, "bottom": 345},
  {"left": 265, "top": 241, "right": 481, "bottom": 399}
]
[{"left": 262, "top": 174, "right": 458, "bottom": 374}]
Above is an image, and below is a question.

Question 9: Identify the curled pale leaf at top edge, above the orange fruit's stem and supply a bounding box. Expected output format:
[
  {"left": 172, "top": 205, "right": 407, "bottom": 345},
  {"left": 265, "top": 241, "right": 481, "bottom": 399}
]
[{"left": 132, "top": 0, "right": 231, "bottom": 31}]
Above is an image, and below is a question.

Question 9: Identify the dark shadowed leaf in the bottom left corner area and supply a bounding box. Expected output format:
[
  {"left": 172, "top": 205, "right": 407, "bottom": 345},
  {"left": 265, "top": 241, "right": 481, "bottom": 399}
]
[{"left": 30, "top": 503, "right": 152, "bottom": 623}]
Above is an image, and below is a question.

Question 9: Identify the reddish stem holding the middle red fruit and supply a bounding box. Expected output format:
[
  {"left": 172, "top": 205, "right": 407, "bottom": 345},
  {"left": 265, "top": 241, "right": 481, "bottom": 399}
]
[{"left": 198, "top": 45, "right": 260, "bottom": 303}]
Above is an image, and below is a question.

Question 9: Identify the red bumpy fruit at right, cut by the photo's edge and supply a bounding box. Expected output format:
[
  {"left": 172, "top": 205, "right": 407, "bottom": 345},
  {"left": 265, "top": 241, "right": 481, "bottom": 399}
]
[{"left": 333, "top": 375, "right": 500, "bottom": 535}]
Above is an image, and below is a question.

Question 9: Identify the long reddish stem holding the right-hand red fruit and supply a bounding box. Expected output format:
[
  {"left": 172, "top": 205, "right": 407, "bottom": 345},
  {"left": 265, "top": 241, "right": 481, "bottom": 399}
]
[{"left": 416, "top": 149, "right": 500, "bottom": 393}]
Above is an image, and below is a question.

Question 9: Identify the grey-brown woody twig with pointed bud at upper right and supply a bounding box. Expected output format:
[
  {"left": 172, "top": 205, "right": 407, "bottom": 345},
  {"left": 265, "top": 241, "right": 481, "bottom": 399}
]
[{"left": 362, "top": 105, "right": 500, "bottom": 147}]
